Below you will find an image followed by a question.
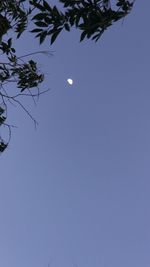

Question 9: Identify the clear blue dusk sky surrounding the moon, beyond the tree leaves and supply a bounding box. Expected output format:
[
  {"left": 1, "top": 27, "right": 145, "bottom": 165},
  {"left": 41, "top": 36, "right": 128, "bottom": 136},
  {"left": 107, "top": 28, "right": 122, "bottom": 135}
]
[{"left": 0, "top": 0, "right": 150, "bottom": 267}]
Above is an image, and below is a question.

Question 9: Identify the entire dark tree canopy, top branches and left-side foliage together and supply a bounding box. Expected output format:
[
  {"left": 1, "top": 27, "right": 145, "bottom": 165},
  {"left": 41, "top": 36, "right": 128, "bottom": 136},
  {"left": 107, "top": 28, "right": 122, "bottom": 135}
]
[{"left": 0, "top": 0, "right": 135, "bottom": 152}]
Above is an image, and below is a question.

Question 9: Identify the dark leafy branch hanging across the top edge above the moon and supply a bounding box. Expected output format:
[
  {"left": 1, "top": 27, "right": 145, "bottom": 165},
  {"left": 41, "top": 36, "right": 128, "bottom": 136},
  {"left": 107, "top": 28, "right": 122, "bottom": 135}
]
[{"left": 30, "top": 0, "right": 133, "bottom": 44}]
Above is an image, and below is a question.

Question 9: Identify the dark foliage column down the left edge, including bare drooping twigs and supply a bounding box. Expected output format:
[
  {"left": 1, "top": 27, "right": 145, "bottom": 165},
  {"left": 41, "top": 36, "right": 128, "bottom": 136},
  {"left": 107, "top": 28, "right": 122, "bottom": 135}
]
[{"left": 0, "top": 0, "right": 44, "bottom": 152}]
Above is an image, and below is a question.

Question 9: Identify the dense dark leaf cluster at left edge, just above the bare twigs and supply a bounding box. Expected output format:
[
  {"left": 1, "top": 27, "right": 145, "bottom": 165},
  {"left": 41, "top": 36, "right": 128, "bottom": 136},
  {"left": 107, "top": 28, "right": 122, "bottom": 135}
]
[{"left": 0, "top": 38, "right": 44, "bottom": 92}]
